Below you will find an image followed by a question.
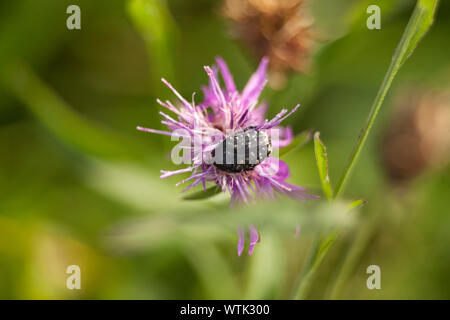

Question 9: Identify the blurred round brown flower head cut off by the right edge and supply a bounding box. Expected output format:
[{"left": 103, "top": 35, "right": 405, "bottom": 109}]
[{"left": 382, "top": 91, "right": 450, "bottom": 181}]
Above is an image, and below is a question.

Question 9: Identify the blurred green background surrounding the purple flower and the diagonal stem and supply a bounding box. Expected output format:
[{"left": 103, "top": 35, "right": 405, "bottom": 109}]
[{"left": 0, "top": 0, "right": 450, "bottom": 299}]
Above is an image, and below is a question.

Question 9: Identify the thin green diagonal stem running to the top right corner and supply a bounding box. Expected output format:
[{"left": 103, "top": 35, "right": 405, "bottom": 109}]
[{"left": 335, "top": 0, "right": 439, "bottom": 196}]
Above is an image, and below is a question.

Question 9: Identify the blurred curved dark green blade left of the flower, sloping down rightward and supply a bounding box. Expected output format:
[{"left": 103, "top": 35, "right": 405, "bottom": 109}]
[{"left": 1, "top": 60, "right": 146, "bottom": 161}]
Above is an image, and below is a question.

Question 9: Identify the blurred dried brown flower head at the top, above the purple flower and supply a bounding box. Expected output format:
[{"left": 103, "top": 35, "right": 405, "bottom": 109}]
[{"left": 222, "top": 0, "right": 314, "bottom": 87}]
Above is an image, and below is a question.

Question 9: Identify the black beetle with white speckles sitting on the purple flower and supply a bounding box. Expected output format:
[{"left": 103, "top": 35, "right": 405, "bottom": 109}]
[{"left": 213, "top": 127, "right": 272, "bottom": 173}]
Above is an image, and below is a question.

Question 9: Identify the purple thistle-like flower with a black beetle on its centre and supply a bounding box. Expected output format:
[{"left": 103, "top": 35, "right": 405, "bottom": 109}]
[{"left": 137, "top": 58, "right": 316, "bottom": 255}]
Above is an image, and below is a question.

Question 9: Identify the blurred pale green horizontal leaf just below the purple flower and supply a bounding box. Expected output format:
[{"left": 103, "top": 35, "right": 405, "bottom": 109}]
[{"left": 104, "top": 199, "right": 356, "bottom": 256}]
